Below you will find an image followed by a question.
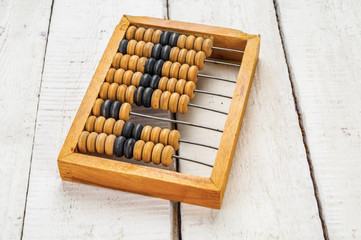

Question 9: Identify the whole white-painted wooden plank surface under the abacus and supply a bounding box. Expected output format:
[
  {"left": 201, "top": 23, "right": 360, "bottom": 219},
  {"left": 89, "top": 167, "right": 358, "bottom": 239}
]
[{"left": 0, "top": 0, "right": 361, "bottom": 240}]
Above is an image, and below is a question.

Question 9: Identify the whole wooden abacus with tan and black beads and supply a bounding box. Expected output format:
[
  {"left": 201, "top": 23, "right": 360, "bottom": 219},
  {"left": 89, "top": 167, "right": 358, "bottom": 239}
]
[{"left": 58, "top": 15, "right": 260, "bottom": 209}]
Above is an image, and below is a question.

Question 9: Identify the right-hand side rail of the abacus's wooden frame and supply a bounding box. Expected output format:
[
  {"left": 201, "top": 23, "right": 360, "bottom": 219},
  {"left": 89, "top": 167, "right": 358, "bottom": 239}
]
[{"left": 211, "top": 36, "right": 260, "bottom": 206}]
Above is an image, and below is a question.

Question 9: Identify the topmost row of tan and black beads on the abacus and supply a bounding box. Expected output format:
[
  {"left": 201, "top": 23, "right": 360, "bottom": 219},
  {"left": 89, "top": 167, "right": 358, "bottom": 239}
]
[{"left": 125, "top": 26, "right": 213, "bottom": 57}]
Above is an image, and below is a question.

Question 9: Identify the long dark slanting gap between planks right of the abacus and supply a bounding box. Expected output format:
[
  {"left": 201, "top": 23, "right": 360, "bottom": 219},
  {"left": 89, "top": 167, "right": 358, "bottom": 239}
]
[{"left": 273, "top": 0, "right": 329, "bottom": 240}]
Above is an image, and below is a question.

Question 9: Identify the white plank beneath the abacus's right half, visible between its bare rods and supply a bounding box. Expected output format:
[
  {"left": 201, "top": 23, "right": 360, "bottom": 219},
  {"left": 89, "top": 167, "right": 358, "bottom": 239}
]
[{"left": 169, "top": 0, "right": 323, "bottom": 239}]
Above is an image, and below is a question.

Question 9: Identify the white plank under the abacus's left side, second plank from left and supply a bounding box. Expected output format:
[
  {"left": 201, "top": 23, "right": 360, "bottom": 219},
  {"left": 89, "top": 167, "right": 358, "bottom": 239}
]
[{"left": 23, "top": 0, "right": 174, "bottom": 239}]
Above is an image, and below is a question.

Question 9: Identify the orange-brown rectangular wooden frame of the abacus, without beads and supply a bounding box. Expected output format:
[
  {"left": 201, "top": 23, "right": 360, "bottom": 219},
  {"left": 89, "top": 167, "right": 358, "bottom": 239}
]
[{"left": 58, "top": 15, "right": 260, "bottom": 209}]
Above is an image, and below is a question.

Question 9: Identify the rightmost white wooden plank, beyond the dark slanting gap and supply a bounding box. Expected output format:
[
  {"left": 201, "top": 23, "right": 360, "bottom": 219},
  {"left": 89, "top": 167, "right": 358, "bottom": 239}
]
[{"left": 276, "top": 0, "right": 361, "bottom": 239}]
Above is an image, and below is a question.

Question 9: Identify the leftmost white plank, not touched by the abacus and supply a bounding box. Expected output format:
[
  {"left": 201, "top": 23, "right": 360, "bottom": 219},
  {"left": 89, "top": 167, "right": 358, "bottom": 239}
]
[{"left": 0, "top": 0, "right": 51, "bottom": 239}]
